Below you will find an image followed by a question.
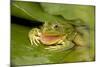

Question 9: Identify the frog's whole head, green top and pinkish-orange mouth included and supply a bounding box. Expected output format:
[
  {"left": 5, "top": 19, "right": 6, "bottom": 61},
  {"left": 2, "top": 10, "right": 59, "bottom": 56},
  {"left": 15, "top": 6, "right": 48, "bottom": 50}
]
[{"left": 40, "top": 22, "right": 74, "bottom": 45}]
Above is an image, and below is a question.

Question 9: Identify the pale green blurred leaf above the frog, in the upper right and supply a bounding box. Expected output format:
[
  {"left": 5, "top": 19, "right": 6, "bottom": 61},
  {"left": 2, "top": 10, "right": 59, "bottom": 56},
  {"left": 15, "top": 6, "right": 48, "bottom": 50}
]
[{"left": 40, "top": 3, "right": 94, "bottom": 23}]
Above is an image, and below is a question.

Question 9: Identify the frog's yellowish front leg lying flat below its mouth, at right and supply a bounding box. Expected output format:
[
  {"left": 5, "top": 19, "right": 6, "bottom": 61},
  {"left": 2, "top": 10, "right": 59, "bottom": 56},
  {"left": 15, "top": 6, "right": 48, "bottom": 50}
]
[{"left": 45, "top": 41, "right": 74, "bottom": 51}]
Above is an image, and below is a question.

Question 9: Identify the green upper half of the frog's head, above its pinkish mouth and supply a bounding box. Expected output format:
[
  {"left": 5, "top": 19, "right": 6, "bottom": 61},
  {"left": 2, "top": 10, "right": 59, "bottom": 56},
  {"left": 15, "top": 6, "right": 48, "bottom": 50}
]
[{"left": 42, "top": 22, "right": 64, "bottom": 35}]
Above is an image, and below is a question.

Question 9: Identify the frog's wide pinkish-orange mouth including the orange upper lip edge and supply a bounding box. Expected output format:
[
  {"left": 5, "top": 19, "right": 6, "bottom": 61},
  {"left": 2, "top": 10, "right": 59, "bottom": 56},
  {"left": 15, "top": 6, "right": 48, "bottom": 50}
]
[{"left": 40, "top": 34, "right": 63, "bottom": 45}]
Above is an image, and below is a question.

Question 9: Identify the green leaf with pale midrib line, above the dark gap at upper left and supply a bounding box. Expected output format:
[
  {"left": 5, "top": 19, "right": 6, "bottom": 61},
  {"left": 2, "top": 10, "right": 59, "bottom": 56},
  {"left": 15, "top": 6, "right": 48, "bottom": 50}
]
[{"left": 11, "top": 1, "right": 55, "bottom": 22}]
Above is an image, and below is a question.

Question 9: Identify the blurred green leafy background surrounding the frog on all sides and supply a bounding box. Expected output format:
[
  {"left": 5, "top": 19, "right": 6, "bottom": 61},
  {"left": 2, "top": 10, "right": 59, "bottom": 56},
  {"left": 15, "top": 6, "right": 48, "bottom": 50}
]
[{"left": 11, "top": 1, "right": 95, "bottom": 65}]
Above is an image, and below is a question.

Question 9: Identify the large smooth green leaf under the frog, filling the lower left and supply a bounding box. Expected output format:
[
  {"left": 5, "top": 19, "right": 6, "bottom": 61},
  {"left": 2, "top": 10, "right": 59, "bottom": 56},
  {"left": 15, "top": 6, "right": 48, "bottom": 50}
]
[{"left": 11, "top": 19, "right": 72, "bottom": 65}]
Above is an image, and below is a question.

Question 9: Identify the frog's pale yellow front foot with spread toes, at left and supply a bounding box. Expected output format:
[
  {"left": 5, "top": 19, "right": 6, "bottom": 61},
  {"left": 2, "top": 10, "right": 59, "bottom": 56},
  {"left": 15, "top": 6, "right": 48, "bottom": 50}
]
[{"left": 28, "top": 28, "right": 40, "bottom": 46}]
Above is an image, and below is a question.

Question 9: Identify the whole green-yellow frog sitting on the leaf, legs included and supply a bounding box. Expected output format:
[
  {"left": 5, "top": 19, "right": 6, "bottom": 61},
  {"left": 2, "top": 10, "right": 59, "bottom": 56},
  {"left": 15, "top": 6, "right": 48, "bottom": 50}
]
[{"left": 28, "top": 21, "right": 84, "bottom": 51}]
